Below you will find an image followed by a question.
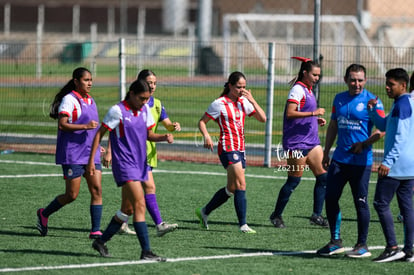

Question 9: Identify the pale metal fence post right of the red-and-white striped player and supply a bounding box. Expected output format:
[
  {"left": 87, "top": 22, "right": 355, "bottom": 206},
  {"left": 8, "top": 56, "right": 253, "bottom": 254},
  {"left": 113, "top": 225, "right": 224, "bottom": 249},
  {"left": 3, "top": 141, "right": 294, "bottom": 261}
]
[{"left": 263, "top": 42, "right": 275, "bottom": 167}]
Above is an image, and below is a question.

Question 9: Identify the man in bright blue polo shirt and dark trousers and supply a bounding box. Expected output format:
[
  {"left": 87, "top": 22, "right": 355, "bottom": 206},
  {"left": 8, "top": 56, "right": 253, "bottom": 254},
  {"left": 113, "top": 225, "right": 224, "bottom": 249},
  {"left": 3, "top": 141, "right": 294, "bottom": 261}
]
[{"left": 317, "top": 64, "right": 384, "bottom": 258}]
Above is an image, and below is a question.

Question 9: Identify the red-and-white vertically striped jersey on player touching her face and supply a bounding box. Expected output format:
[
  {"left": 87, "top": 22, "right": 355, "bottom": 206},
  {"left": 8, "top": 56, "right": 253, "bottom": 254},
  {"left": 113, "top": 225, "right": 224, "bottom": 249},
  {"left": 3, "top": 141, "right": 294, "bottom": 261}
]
[{"left": 206, "top": 95, "right": 256, "bottom": 154}]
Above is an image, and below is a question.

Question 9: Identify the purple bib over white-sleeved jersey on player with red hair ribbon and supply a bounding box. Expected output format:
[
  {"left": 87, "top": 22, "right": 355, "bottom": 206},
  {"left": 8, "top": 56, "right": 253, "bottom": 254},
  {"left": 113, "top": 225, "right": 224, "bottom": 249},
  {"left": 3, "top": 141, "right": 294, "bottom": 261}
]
[{"left": 283, "top": 82, "right": 320, "bottom": 150}]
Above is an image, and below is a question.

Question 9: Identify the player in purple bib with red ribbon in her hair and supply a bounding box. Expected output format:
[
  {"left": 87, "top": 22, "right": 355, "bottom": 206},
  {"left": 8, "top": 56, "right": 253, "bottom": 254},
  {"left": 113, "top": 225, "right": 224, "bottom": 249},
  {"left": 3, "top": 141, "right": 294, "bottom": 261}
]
[{"left": 270, "top": 57, "right": 328, "bottom": 228}]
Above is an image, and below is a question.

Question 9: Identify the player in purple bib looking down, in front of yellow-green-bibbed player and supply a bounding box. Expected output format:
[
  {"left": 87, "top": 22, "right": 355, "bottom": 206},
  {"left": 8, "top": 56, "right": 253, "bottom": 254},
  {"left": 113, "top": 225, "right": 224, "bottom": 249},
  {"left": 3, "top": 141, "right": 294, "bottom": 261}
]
[{"left": 88, "top": 80, "right": 174, "bottom": 261}]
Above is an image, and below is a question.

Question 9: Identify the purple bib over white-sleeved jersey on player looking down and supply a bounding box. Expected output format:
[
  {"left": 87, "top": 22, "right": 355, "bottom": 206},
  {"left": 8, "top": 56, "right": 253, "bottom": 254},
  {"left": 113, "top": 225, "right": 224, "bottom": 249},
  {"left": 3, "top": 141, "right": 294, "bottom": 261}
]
[{"left": 102, "top": 101, "right": 154, "bottom": 185}]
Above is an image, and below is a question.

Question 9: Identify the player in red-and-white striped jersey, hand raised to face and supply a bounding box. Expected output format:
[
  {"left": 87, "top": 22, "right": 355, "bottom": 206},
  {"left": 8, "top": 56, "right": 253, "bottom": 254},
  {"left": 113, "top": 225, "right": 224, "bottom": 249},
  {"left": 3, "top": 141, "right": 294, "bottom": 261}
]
[{"left": 195, "top": 72, "right": 266, "bottom": 233}]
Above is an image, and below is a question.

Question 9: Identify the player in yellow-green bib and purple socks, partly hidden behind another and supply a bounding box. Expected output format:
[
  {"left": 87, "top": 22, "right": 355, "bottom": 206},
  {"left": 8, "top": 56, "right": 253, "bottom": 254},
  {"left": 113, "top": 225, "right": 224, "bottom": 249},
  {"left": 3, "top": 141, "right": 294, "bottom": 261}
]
[{"left": 111, "top": 69, "right": 181, "bottom": 237}]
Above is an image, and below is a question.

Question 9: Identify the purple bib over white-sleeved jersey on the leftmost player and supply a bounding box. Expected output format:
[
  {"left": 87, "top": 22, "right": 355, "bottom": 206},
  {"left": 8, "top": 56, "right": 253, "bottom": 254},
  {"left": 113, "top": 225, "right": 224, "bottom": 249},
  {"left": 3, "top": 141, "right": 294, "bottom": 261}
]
[{"left": 56, "top": 91, "right": 100, "bottom": 165}]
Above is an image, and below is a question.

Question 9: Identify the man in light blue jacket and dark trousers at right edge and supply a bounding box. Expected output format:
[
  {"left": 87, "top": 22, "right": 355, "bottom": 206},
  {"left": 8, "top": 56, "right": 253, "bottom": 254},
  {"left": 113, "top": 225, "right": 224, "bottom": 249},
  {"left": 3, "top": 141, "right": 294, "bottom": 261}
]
[{"left": 368, "top": 68, "right": 414, "bottom": 262}]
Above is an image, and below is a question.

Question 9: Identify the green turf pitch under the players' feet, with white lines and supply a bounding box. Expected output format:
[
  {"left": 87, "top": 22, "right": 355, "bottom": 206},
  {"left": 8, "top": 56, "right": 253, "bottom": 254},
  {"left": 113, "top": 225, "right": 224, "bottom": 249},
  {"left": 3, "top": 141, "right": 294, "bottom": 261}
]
[{"left": 0, "top": 153, "right": 413, "bottom": 274}]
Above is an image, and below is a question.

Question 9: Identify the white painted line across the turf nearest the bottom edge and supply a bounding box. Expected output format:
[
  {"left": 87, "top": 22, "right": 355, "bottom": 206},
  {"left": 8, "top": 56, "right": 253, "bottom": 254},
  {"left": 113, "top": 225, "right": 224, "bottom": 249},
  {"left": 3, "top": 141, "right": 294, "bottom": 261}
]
[{"left": 0, "top": 246, "right": 385, "bottom": 272}]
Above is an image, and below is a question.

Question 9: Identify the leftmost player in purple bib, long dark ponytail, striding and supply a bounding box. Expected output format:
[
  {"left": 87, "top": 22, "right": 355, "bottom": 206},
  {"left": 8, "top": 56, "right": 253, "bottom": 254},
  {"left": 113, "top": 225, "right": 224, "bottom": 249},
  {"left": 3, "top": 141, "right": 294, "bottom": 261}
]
[{"left": 37, "top": 67, "right": 102, "bottom": 239}]
